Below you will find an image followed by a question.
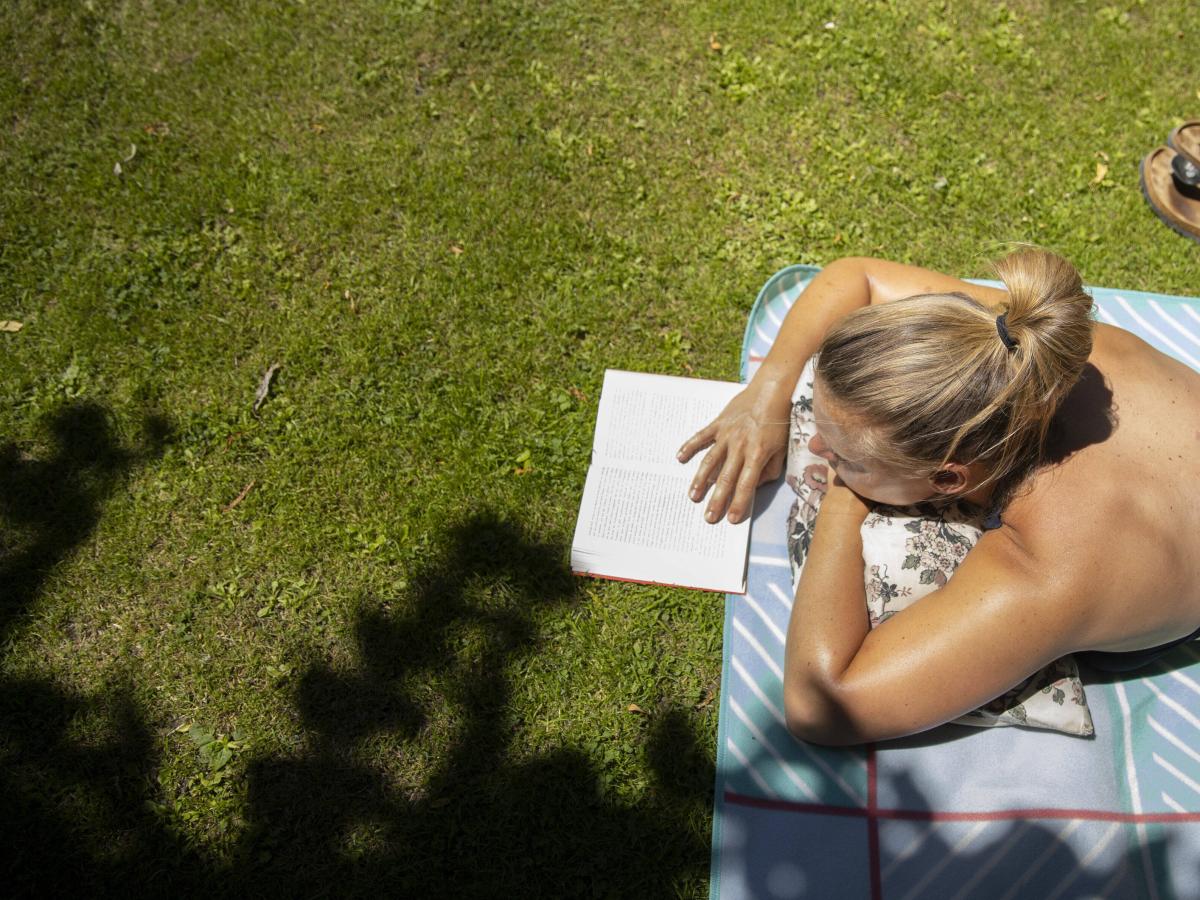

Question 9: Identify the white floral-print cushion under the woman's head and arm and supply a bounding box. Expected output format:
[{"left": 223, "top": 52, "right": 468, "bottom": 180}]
[{"left": 786, "top": 360, "right": 1093, "bottom": 734}]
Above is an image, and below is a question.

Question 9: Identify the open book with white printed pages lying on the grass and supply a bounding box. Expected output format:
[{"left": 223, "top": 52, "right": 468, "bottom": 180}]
[{"left": 571, "top": 368, "right": 750, "bottom": 594}]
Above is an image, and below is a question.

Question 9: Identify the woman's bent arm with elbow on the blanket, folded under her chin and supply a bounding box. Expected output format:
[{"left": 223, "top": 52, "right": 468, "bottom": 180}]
[{"left": 784, "top": 482, "right": 1086, "bottom": 744}]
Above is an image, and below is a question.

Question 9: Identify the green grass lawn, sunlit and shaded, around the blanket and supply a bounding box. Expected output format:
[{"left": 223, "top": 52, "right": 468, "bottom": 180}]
[{"left": 0, "top": 0, "right": 1200, "bottom": 896}]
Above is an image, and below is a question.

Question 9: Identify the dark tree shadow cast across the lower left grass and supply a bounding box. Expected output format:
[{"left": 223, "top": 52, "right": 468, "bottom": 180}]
[{"left": 0, "top": 487, "right": 714, "bottom": 898}]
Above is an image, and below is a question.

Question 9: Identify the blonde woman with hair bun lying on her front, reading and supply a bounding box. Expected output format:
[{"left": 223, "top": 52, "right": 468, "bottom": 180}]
[{"left": 679, "top": 250, "right": 1200, "bottom": 744}]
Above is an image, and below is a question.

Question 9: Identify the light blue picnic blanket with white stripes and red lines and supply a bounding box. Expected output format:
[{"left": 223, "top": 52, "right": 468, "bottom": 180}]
[{"left": 710, "top": 265, "right": 1200, "bottom": 900}]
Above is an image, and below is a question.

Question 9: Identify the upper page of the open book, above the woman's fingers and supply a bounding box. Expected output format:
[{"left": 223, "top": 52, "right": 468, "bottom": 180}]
[{"left": 593, "top": 368, "right": 744, "bottom": 475}]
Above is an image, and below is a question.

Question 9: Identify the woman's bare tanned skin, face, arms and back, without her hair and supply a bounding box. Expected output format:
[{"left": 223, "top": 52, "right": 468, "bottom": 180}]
[{"left": 679, "top": 258, "right": 1200, "bottom": 744}]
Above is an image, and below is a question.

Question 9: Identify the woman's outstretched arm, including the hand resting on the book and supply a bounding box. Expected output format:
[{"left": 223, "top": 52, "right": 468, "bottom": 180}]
[{"left": 678, "top": 257, "right": 1006, "bottom": 522}]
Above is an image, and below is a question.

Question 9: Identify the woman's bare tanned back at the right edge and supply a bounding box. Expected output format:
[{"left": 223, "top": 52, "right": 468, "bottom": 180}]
[{"left": 1004, "top": 324, "right": 1200, "bottom": 652}]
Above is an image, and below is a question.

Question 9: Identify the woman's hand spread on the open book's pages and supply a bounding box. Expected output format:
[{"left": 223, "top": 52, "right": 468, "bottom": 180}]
[{"left": 678, "top": 383, "right": 794, "bottom": 523}]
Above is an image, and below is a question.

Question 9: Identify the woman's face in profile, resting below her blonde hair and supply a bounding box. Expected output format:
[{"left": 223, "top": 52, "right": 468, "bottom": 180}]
[{"left": 809, "top": 378, "right": 937, "bottom": 506}]
